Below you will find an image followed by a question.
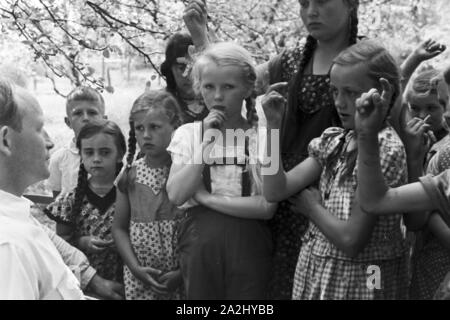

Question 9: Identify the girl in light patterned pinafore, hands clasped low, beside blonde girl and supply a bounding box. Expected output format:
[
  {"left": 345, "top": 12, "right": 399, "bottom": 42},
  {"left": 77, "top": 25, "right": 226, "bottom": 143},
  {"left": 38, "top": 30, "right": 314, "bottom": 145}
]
[{"left": 113, "top": 91, "right": 182, "bottom": 300}]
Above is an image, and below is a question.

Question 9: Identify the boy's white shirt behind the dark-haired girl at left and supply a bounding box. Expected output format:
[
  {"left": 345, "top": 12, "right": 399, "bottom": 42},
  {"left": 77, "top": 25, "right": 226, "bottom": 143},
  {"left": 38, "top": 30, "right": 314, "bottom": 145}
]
[{"left": 47, "top": 139, "right": 80, "bottom": 194}]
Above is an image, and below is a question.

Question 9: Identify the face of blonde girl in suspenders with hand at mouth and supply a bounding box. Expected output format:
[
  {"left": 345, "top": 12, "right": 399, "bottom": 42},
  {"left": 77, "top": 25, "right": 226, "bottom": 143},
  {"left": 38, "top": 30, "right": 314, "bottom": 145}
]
[{"left": 200, "top": 62, "right": 251, "bottom": 115}]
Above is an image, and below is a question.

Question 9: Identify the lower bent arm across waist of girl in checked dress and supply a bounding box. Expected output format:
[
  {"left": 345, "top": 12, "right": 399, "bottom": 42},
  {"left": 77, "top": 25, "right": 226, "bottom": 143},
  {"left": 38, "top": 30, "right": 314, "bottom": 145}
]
[{"left": 289, "top": 188, "right": 377, "bottom": 258}]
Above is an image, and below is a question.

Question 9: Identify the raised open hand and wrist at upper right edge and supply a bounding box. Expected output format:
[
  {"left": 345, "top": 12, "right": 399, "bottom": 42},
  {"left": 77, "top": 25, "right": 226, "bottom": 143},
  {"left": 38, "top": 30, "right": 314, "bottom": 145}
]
[{"left": 400, "top": 39, "right": 446, "bottom": 88}]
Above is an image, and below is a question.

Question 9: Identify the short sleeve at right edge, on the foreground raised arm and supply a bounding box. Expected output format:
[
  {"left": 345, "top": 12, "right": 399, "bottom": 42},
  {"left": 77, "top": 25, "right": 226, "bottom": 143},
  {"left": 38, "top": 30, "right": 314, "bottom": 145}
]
[{"left": 419, "top": 169, "right": 450, "bottom": 227}]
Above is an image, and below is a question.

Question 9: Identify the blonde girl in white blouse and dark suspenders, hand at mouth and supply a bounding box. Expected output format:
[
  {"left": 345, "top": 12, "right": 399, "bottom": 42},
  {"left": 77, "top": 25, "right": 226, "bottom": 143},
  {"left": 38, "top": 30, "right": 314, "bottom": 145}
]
[{"left": 167, "top": 43, "right": 276, "bottom": 300}]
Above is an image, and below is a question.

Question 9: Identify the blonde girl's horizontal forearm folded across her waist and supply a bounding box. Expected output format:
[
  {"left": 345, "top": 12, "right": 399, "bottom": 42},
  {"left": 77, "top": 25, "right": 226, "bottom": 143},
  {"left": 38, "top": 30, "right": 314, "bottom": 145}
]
[{"left": 195, "top": 187, "right": 277, "bottom": 220}]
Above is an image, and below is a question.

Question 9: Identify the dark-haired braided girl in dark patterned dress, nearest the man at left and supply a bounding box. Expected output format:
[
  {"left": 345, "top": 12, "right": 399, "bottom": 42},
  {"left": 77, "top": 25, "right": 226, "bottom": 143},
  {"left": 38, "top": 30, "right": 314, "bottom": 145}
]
[{"left": 45, "top": 120, "right": 126, "bottom": 282}]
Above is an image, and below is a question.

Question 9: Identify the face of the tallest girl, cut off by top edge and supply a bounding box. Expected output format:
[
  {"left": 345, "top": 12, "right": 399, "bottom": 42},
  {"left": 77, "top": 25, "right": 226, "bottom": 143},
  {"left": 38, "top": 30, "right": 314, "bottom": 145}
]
[{"left": 299, "top": 0, "right": 351, "bottom": 41}]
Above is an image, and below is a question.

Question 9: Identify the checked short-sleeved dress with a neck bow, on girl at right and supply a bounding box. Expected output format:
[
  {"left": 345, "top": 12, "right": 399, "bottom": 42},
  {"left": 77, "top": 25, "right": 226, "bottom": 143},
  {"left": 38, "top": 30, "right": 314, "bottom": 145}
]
[{"left": 293, "top": 127, "right": 408, "bottom": 300}]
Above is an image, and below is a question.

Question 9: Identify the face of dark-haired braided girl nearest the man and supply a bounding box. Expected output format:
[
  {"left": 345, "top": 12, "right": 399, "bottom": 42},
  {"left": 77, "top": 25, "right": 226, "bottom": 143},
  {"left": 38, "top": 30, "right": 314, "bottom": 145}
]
[{"left": 80, "top": 133, "right": 123, "bottom": 180}]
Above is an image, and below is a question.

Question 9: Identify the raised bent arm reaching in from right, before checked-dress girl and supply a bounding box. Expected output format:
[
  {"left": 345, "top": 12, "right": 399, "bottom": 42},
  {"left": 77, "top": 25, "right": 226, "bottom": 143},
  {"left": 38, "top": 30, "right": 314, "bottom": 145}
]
[{"left": 355, "top": 79, "right": 433, "bottom": 214}]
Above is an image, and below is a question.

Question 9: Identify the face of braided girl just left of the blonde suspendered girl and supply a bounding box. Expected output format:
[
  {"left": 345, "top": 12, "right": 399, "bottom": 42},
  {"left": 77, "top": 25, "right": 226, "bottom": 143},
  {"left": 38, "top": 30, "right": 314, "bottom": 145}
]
[{"left": 134, "top": 108, "right": 174, "bottom": 157}]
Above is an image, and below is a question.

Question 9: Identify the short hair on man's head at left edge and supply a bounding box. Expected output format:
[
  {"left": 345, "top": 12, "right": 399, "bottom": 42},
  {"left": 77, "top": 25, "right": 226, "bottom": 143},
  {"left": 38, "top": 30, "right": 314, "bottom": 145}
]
[{"left": 0, "top": 79, "right": 22, "bottom": 131}]
